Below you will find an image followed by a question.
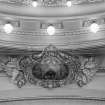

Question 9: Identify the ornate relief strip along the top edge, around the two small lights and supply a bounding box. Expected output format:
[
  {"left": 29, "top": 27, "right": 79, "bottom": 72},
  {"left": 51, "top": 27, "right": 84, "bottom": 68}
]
[{"left": 0, "top": 0, "right": 105, "bottom": 7}]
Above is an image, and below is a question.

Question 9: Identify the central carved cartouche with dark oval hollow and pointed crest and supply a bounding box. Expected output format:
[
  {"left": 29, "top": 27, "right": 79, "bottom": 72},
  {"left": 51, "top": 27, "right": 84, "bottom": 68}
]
[{"left": 19, "top": 45, "right": 80, "bottom": 88}]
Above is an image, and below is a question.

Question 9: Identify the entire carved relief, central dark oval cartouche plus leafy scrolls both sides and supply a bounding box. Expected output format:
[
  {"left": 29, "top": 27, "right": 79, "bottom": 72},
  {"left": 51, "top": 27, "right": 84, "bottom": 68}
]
[{"left": 0, "top": 45, "right": 97, "bottom": 89}]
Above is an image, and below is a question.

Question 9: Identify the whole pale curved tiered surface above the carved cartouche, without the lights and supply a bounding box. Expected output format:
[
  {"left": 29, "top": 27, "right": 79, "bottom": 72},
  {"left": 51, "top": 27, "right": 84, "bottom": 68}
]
[{"left": 0, "top": 0, "right": 105, "bottom": 50}]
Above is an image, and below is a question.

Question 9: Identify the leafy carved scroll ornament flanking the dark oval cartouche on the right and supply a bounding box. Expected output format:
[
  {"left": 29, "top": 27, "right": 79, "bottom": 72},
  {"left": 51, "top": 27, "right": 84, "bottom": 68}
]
[{"left": 76, "top": 57, "right": 97, "bottom": 87}]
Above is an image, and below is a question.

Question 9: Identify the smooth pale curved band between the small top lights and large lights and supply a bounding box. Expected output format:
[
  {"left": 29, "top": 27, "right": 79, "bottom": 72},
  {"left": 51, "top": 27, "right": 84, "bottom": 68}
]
[{"left": 0, "top": 3, "right": 105, "bottom": 18}]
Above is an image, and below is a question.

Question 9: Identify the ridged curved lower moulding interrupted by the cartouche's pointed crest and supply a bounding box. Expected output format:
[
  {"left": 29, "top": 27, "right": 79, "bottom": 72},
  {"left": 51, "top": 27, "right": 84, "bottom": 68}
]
[{"left": 0, "top": 39, "right": 105, "bottom": 51}]
